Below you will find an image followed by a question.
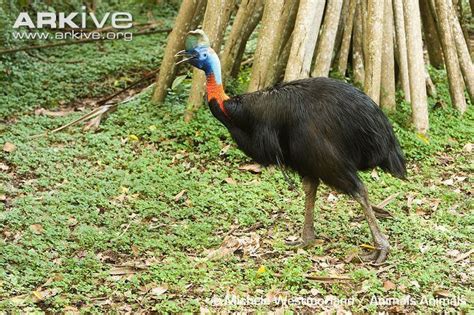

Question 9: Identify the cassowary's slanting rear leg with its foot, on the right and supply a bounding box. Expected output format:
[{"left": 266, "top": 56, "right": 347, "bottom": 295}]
[{"left": 355, "top": 187, "right": 390, "bottom": 264}]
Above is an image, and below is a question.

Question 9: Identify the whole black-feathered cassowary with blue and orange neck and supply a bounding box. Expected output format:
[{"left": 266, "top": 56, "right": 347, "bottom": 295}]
[{"left": 176, "top": 30, "right": 406, "bottom": 263}]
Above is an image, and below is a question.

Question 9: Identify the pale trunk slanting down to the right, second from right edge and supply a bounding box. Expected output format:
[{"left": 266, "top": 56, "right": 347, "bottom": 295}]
[{"left": 435, "top": 0, "right": 466, "bottom": 113}]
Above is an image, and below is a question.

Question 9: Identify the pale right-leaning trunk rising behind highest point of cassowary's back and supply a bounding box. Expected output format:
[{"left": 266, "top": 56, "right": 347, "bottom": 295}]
[{"left": 311, "top": 0, "right": 342, "bottom": 77}]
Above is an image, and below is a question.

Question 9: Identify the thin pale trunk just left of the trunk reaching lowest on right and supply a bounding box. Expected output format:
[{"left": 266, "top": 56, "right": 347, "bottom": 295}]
[{"left": 392, "top": 0, "right": 411, "bottom": 102}]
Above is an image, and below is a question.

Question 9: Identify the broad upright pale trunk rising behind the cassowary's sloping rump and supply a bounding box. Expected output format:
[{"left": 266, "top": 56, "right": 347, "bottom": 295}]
[{"left": 364, "top": 0, "right": 384, "bottom": 104}]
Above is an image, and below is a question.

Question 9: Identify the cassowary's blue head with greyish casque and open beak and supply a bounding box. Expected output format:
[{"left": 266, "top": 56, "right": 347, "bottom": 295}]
[{"left": 176, "top": 30, "right": 220, "bottom": 78}]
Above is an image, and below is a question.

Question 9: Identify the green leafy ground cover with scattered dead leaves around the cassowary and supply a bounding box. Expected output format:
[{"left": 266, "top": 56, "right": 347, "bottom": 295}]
[{"left": 0, "top": 21, "right": 474, "bottom": 313}]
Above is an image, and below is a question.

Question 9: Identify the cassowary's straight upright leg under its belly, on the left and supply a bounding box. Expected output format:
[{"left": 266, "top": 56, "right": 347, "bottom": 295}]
[{"left": 301, "top": 177, "right": 319, "bottom": 246}]
